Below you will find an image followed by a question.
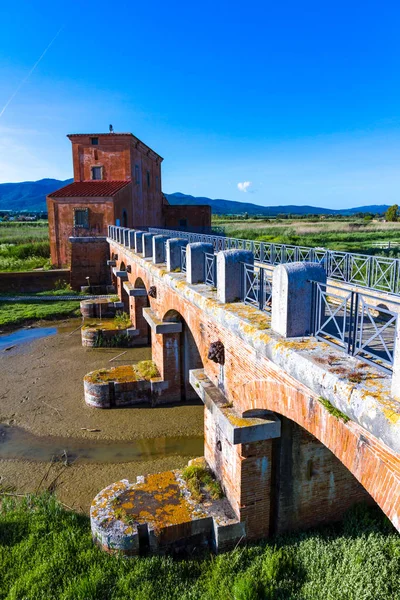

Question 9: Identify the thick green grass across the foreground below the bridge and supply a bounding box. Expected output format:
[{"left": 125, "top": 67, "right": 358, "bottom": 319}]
[{"left": 0, "top": 496, "right": 400, "bottom": 600}]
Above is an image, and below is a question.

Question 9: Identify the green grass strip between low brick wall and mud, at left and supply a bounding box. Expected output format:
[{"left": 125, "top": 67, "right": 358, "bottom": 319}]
[{"left": 0, "top": 289, "right": 80, "bottom": 329}]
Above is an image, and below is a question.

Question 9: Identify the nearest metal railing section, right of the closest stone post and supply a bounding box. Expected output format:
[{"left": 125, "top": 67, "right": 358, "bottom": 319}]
[{"left": 311, "top": 282, "right": 400, "bottom": 372}]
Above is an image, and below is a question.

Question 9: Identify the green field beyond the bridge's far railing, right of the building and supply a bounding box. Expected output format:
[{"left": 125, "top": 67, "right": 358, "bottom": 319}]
[{"left": 213, "top": 219, "right": 400, "bottom": 256}]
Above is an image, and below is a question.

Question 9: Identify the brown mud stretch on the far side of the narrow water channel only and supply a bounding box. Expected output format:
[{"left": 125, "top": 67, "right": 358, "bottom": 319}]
[{"left": 0, "top": 320, "right": 203, "bottom": 440}]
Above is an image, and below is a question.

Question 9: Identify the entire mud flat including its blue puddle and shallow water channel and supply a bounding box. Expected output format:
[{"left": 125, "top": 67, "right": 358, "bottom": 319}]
[{"left": 0, "top": 319, "right": 203, "bottom": 512}]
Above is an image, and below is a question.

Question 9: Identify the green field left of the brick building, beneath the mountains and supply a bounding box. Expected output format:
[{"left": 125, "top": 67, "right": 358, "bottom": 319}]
[{"left": 0, "top": 221, "right": 50, "bottom": 272}]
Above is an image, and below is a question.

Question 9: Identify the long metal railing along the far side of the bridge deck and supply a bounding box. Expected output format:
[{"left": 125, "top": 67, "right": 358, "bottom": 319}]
[{"left": 149, "top": 227, "right": 400, "bottom": 294}]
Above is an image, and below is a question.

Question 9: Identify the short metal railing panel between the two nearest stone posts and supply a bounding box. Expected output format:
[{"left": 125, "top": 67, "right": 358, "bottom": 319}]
[{"left": 242, "top": 263, "right": 272, "bottom": 312}]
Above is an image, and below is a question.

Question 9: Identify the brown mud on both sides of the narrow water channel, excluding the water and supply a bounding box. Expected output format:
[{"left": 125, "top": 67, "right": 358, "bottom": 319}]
[{"left": 0, "top": 320, "right": 203, "bottom": 512}]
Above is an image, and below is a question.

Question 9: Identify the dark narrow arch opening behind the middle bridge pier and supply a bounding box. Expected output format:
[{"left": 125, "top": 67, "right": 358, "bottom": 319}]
[{"left": 163, "top": 310, "right": 203, "bottom": 401}]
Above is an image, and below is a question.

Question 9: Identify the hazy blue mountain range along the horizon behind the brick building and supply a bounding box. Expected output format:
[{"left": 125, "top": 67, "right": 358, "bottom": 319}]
[{"left": 0, "top": 179, "right": 388, "bottom": 217}]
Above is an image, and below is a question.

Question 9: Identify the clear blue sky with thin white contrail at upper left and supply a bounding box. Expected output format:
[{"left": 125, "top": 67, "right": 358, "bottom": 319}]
[{"left": 0, "top": 0, "right": 400, "bottom": 208}]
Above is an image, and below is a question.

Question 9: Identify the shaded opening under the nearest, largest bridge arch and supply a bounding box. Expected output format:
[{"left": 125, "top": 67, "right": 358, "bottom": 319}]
[{"left": 264, "top": 411, "right": 378, "bottom": 534}]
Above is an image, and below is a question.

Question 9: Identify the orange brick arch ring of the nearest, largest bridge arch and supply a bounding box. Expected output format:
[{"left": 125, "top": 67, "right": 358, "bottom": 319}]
[{"left": 242, "top": 377, "right": 400, "bottom": 530}]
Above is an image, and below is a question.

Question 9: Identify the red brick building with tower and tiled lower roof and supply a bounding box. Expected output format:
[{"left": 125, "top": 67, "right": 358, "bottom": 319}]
[{"left": 47, "top": 133, "right": 211, "bottom": 267}]
